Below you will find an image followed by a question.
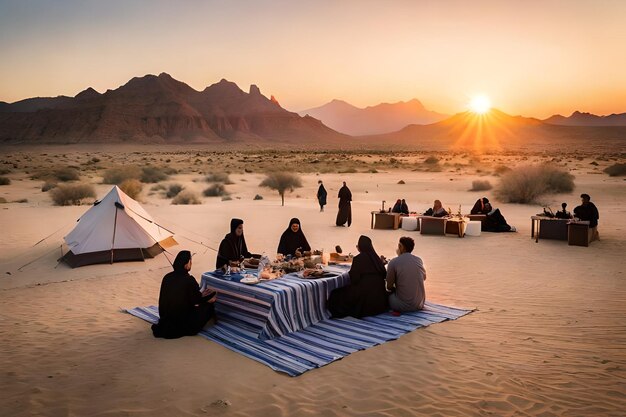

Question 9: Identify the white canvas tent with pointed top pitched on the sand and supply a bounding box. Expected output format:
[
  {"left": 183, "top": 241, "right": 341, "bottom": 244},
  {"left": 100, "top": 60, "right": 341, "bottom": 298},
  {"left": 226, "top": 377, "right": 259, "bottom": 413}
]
[{"left": 61, "top": 186, "right": 177, "bottom": 268}]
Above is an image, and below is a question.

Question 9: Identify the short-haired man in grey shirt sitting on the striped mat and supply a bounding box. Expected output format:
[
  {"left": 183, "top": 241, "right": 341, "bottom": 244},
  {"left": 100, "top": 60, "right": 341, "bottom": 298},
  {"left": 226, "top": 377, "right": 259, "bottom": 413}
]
[{"left": 386, "top": 237, "right": 426, "bottom": 312}]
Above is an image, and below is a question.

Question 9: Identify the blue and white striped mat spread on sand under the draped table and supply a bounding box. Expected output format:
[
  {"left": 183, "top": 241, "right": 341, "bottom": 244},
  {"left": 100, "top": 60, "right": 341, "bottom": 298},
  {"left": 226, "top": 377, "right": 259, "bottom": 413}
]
[{"left": 126, "top": 302, "right": 473, "bottom": 376}]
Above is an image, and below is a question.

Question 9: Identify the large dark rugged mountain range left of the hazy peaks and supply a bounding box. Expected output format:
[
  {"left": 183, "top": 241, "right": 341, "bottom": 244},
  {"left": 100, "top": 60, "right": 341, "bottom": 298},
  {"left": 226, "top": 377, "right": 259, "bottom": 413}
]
[{"left": 0, "top": 73, "right": 347, "bottom": 143}]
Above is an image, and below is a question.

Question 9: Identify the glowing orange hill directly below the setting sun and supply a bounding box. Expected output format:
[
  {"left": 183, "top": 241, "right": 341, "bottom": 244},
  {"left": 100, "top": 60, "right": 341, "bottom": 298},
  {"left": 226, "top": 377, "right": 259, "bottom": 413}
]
[{"left": 360, "top": 109, "right": 626, "bottom": 152}]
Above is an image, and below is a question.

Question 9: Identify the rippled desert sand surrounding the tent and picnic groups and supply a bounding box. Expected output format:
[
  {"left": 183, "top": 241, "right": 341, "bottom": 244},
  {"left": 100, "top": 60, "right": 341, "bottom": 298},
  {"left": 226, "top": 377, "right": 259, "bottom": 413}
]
[{"left": 0, "top": 148, "right": 626, "bottom": 417}]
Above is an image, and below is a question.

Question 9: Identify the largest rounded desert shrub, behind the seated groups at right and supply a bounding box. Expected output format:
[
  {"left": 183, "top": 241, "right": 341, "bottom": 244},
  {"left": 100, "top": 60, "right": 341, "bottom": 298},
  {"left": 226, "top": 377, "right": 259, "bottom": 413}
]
[{"left": 496, "top": 165, "right": 574, "bottom": 204}]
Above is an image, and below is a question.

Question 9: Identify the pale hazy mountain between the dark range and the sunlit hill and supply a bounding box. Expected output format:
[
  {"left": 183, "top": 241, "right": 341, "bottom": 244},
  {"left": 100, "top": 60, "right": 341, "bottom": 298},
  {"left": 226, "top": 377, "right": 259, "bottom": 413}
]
[{"left": 298, "top": 99, "right": 448, "bottom": 136}]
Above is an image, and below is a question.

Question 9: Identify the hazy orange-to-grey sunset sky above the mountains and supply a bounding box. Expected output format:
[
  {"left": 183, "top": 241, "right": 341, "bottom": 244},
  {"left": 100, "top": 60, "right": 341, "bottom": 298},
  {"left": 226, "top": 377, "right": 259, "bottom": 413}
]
[{"left": 0, "top": 0, "right": 626, "bottom": 118}]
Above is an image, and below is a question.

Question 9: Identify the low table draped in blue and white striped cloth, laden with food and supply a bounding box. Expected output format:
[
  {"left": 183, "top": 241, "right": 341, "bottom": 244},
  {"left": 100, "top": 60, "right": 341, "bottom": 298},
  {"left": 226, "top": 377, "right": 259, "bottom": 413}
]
[{"left": 201, "top": 266, "right": 350, "bottom": 340}]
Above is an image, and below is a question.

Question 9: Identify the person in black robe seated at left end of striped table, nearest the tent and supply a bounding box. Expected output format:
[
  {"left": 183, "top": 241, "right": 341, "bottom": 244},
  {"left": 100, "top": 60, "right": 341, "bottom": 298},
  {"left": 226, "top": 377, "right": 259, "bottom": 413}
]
[{"left": 152, "top": 250, "right": 217, "bottom": 339}]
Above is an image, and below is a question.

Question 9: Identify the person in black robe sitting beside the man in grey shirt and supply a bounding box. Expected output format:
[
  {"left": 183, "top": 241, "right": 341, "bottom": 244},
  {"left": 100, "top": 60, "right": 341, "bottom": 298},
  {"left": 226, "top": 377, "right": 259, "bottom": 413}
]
[{"left": 328, "top": 236, "right": 388, "bottom": 318}]
